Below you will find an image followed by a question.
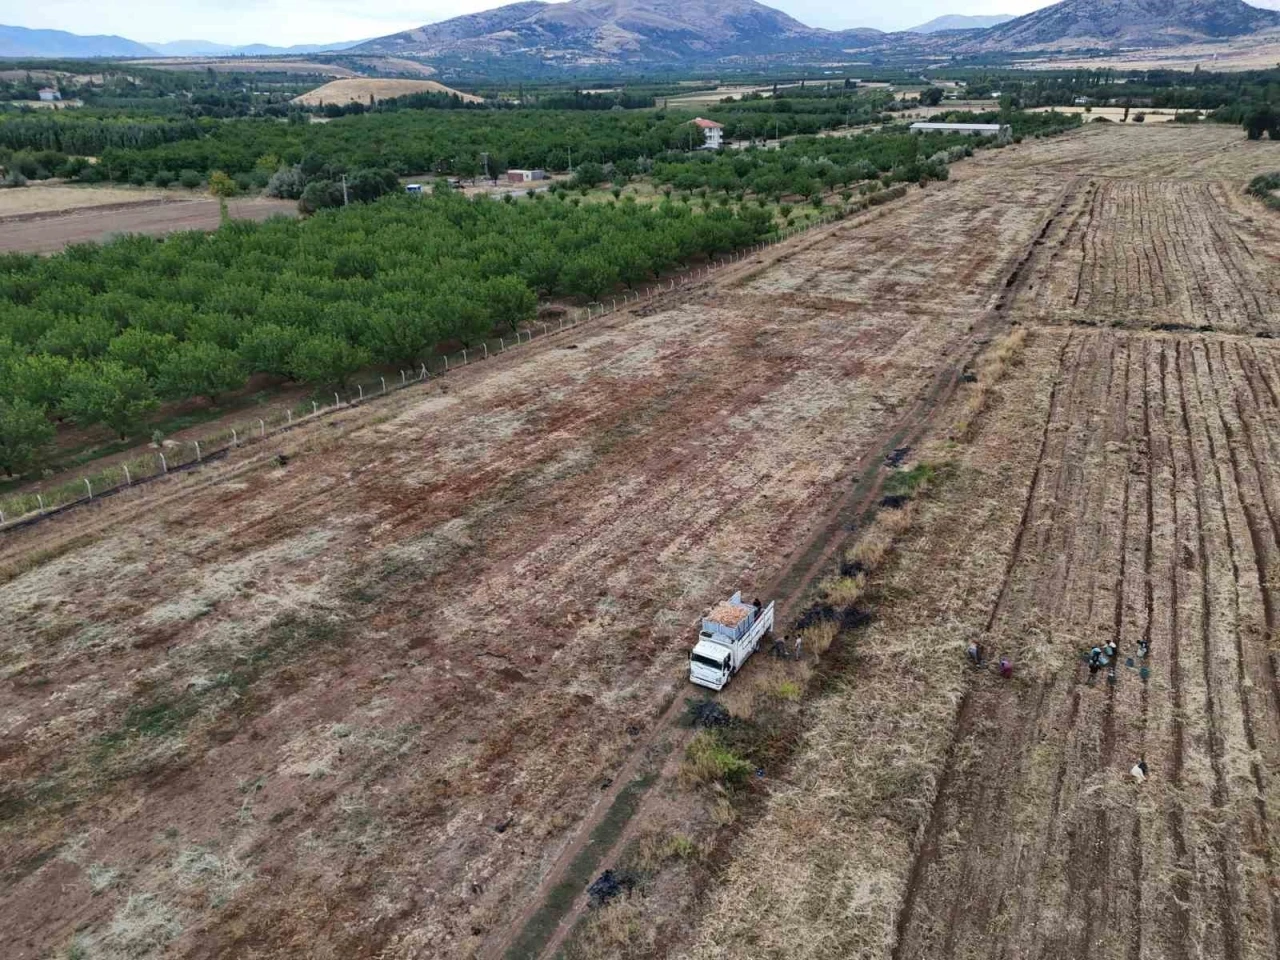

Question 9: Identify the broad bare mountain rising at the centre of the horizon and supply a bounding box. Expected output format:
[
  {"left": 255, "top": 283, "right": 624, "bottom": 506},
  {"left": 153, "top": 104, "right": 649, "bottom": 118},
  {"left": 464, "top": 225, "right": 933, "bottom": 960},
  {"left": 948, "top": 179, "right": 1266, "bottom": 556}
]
[{"left": 352, "top": 0, "right": 840, "bottom": 61}]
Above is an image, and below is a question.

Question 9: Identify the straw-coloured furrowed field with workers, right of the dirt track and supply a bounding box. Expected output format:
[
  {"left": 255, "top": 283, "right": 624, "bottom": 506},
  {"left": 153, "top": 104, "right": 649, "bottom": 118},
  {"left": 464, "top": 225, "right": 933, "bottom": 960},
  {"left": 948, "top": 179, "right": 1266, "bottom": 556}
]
[{"left": 685, "top": 124, "right": 1280, "bottom": 960}]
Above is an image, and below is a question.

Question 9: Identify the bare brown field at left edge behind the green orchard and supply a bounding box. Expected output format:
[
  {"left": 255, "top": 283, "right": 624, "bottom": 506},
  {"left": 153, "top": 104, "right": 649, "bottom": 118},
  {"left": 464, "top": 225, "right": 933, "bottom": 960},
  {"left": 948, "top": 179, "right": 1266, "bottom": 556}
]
[{"left": 0, "top": 197, "right": 298, "bottom": 253}]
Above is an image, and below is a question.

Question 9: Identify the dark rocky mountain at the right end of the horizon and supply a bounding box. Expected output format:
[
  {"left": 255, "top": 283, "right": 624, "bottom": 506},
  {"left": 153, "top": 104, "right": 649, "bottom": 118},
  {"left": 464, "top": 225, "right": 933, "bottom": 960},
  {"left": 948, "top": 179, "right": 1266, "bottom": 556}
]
[{"left": 957, "top": 0, "right": 1280, "bottom": 52}]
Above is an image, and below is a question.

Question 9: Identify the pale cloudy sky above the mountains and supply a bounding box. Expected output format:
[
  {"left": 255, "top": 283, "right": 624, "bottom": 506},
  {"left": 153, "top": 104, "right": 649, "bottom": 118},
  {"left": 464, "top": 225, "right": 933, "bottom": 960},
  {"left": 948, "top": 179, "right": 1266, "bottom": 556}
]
[{"left": 0, "top": 0, "right": 1280, "bottom": 46}]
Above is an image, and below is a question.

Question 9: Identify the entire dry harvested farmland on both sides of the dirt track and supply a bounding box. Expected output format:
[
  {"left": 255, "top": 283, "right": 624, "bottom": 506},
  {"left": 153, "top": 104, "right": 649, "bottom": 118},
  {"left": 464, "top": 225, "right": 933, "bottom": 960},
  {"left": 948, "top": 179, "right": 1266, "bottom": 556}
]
[{"left": 0, "top": 124, "right": 1280, "bottom": 960}]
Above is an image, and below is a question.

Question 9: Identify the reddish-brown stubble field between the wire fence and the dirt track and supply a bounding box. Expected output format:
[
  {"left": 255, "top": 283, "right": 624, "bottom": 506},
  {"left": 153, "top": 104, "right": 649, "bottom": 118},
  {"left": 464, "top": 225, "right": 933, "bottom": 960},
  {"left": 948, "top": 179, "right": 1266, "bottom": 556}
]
[{"left": 0, "top": 129, "right": 1059, "bottom": 956}]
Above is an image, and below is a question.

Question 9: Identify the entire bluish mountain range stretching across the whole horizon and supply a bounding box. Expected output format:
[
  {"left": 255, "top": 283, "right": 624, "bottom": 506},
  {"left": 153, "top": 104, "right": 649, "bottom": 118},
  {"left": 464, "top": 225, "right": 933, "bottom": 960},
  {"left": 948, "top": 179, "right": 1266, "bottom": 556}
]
[{"left": 0, "top": 0, "right": 1280, "bottom": 68}]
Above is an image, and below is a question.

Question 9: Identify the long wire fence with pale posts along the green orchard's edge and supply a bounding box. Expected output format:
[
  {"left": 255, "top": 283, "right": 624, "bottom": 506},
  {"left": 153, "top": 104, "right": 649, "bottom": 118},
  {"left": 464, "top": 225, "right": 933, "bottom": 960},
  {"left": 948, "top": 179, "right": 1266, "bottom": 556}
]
[{"left": 0, "top": 184, "right": 906, "bottom": 532}]
